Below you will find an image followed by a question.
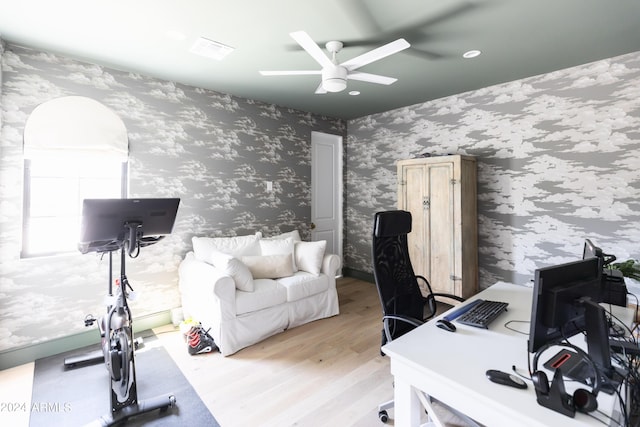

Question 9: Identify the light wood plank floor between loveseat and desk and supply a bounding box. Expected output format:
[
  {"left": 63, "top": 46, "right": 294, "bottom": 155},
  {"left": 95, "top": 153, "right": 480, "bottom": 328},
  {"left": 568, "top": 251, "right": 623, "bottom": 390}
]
[{"left": 0, "top": 278, "right": 470, "bottom": 427}]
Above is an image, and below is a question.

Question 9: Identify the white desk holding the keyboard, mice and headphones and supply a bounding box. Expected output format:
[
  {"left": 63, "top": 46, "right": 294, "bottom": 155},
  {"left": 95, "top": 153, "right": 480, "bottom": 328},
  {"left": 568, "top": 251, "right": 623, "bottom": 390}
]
[{"left": 382, "top": 283, "right": 632, "bottom": 427}]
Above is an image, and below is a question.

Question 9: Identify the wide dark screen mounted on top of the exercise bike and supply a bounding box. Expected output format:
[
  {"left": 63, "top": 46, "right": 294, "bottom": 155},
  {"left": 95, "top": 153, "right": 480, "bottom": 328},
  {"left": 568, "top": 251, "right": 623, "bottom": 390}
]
[{"left": 78, "top": 198, "right": 180, "bottom": 253}]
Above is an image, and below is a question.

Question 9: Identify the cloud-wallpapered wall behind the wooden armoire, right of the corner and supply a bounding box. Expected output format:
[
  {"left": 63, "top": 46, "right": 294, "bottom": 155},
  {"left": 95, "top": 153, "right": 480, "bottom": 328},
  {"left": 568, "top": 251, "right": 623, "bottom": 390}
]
[{"left": 345, "top": 52, "right": 640, "bottom": 288}]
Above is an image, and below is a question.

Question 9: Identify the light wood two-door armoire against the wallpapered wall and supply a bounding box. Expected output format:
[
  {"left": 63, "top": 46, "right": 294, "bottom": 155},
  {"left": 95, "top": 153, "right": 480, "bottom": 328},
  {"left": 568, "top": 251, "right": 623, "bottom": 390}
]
[{"left": 398, "top": 155, "right": 478, "bottom": 298}]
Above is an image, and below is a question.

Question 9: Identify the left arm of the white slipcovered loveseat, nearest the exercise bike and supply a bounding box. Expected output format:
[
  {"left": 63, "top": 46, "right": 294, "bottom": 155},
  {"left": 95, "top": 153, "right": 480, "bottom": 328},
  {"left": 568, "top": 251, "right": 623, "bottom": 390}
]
[{"left": 178, "top": 252, "right": 236, "bottom": 319}]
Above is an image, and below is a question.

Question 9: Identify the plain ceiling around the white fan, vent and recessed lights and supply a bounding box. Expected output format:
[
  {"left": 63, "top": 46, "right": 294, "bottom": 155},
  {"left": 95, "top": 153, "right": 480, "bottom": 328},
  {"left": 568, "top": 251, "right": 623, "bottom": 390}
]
[{"left": 0, "top": 0, "right": 640, "bottom": 119}]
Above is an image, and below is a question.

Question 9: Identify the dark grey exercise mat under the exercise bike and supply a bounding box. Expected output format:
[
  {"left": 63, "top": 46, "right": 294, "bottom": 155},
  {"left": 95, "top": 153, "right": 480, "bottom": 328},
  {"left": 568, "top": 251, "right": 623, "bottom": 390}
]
[{"left": 30, "top": 332, "right": 219, "bottom": 427}]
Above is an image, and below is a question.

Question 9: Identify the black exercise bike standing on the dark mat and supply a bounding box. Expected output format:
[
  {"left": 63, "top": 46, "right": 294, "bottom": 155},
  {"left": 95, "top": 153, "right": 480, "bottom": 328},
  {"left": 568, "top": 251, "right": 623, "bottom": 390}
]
[{"left": 65, "top": 199, "right": 179, "bottom": 426}]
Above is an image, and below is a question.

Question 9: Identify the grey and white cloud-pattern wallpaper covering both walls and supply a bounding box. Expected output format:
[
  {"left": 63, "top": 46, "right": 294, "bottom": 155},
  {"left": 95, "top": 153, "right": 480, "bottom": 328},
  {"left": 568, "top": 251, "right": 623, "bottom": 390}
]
[{"left": 0, "top": 38, "right": 640, "bottom": 352}]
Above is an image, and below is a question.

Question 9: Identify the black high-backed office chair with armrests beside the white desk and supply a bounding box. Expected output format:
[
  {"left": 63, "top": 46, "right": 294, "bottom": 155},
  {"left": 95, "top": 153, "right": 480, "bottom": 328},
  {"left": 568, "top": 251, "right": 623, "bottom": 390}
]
[{"left": 372, "top": 210, "right": 477, "bottom": 425}]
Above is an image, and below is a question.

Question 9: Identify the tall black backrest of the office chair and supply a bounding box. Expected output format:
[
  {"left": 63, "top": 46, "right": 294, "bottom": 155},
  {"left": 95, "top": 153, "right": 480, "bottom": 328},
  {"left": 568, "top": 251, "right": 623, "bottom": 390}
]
[{"left": 372, "top": 210, "right": 425, "bottom": 338}]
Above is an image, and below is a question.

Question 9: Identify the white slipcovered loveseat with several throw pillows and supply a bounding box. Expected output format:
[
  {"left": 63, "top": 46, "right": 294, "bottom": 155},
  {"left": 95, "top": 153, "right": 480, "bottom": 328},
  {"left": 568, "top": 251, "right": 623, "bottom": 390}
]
[{"left": 179, "top": 231, "right": 340, "bottom": 356}]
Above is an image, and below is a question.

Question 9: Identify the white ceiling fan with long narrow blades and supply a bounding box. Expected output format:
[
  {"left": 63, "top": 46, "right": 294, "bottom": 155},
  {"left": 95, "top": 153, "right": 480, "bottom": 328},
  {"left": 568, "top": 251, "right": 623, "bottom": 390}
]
[{"left": 260, "top": 31, "right": 410, "bottom": 94}]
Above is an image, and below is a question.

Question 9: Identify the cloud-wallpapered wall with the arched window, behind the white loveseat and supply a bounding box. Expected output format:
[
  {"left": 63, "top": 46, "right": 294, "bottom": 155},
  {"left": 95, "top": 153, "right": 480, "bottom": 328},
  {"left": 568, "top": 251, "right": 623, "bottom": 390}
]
[{"left": 0, "top": 44, "right": 346, "bottom": 351}]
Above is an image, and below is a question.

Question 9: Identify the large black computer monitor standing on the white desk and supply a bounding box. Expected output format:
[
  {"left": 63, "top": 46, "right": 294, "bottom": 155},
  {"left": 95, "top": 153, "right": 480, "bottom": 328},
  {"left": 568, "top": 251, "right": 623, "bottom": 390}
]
[{"left": 529, "top": 258, "right": 602, "bottom": 353}]
